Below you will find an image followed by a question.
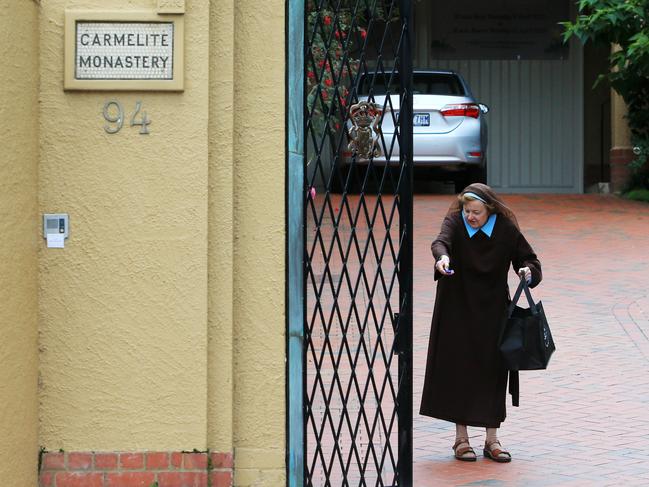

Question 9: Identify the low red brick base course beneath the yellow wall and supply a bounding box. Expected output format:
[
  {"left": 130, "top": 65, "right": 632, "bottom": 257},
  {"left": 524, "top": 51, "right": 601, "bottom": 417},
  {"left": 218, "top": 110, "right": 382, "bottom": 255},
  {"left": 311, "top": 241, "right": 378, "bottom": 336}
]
[{"left": 39, "top": 452, "right": 233, "bottom": 487}]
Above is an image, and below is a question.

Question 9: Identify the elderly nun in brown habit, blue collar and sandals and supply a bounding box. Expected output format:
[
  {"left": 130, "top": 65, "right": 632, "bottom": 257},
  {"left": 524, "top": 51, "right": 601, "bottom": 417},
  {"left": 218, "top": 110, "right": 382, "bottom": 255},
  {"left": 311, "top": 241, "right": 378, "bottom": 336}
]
[{"left": 420, "top": 183, "right": 542, "bottom": 463}]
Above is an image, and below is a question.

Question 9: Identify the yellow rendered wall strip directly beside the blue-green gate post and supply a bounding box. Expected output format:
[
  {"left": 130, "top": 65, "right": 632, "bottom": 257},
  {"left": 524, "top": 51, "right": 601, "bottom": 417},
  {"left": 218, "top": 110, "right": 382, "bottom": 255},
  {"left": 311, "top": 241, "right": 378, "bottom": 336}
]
[{"left": 233, "top": 0, "right": 286, "bottom": 487}]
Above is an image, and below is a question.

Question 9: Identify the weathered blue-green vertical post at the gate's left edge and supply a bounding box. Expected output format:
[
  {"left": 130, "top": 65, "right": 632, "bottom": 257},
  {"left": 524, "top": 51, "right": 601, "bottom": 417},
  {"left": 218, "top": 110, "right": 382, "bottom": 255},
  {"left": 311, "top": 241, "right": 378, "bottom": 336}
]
[{"left": 285, "top": 0, "right": 306, "bottom": 487}]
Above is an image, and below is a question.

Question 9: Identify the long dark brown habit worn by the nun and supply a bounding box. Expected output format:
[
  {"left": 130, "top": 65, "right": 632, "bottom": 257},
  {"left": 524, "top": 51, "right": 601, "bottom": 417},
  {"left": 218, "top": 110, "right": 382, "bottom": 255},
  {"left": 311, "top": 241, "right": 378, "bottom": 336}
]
[{"left": 420, "top": 211, "right": 541, "bottom": 428}]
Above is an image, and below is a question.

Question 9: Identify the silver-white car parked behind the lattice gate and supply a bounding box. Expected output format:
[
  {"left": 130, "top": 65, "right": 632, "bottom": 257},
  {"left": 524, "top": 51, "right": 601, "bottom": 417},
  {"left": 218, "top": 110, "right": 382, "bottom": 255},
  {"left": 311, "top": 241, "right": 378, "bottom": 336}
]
[{"left": 340, "top": 70, "right": 489, "bottom": 192}]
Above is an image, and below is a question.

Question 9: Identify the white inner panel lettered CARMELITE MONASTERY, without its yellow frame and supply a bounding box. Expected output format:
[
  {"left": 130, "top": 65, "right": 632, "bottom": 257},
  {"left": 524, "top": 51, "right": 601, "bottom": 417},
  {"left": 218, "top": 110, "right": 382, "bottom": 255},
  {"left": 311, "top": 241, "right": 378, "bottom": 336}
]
[{"left": 74, "top": 21, "right": 174, "bottom": 80}]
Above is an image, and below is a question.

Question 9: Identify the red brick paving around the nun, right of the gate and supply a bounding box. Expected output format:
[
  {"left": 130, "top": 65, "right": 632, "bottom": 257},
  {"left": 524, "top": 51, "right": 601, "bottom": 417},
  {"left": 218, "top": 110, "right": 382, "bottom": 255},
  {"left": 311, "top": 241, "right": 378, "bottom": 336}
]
[{"left": 414, "top": 195, "right": 649, "bottom": 487}]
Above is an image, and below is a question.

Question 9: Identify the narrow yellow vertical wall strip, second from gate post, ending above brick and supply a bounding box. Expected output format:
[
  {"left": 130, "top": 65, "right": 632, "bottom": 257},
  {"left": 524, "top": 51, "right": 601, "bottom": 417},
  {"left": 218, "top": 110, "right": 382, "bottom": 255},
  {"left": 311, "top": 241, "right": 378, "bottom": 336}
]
[{"left": 207, "top": 0, "right": 235, "bottom": 452}]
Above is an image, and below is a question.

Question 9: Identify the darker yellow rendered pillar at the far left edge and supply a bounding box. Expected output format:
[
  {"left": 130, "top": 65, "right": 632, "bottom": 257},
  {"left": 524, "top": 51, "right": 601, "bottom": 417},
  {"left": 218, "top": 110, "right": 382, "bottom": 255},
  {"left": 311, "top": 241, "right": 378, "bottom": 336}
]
[{"left": 0, "top": 0, "right": 40, "bottom": 486}]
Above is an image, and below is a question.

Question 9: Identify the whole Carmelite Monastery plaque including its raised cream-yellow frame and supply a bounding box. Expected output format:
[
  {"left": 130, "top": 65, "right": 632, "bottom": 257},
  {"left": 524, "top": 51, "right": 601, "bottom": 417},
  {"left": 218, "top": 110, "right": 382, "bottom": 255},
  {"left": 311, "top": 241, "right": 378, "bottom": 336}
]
[{"left": 65, "top": 11, "right": 183, "bottom": 90}]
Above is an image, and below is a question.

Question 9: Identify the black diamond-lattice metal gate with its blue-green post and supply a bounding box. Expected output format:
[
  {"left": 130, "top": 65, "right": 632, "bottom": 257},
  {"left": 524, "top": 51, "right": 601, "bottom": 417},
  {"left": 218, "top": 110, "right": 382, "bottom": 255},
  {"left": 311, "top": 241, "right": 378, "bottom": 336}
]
[{"left": 287, "top": 0, "right": 413, "bottom": 487}]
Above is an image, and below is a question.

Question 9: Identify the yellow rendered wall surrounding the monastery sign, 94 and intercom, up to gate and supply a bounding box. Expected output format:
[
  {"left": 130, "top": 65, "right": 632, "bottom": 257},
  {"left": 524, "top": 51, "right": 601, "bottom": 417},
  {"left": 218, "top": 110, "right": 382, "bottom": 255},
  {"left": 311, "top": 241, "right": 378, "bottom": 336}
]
[{"left": 40, "top": 0, "right": 286, "bottom": 480}]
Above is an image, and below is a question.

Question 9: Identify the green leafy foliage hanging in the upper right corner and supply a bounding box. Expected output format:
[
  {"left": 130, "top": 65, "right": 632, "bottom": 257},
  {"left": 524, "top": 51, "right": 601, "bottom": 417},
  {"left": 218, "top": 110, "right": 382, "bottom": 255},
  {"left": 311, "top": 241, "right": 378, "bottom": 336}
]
[{"left": 562, "top": 0, "right": 649, "bottom": 188}]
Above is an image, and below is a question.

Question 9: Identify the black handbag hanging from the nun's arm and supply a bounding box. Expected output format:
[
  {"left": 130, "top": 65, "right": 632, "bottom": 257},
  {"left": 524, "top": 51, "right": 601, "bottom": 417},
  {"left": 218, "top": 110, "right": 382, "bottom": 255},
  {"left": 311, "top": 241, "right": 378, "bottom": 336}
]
[{"left": 498, "top": 277, "right": 556, "bottom": 406}]
